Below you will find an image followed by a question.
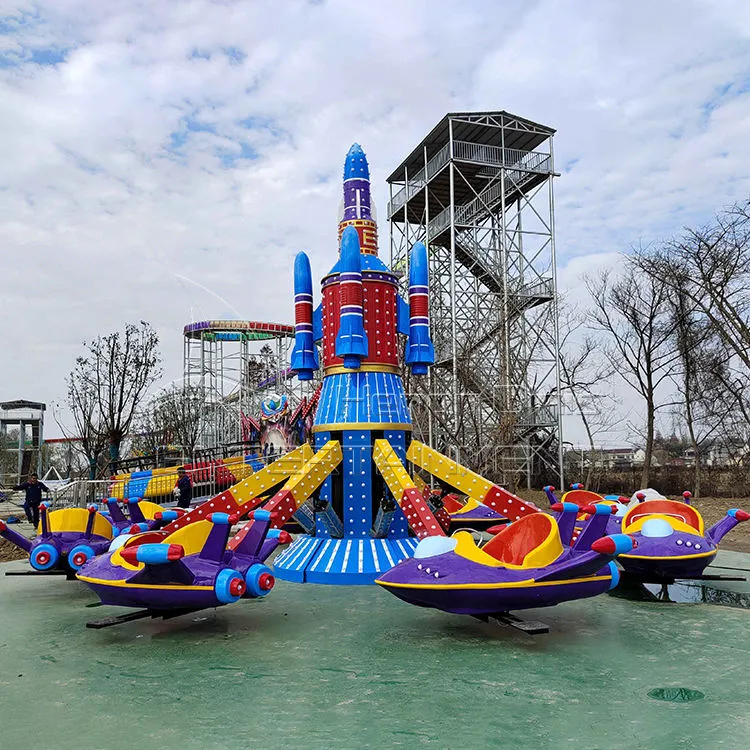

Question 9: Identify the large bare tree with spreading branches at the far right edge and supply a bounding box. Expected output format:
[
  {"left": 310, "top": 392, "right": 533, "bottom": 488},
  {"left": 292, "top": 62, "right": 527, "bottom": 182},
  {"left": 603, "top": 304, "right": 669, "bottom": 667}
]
[{"left": 635, "top": 201, "right": 750, "bottom": 492}]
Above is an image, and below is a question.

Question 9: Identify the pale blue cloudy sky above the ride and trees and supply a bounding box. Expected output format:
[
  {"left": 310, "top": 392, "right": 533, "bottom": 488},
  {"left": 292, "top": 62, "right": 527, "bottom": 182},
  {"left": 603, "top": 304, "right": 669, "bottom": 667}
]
[{"left": 0, "top": 0, "right": 750, "bottom": 444}]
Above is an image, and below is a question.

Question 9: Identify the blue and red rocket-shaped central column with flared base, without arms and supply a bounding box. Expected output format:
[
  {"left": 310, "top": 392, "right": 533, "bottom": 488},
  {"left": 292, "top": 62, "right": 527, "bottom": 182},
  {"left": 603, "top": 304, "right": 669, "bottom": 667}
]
[{"left": 274, "top": 144, "right": 434, "bottom": 584}]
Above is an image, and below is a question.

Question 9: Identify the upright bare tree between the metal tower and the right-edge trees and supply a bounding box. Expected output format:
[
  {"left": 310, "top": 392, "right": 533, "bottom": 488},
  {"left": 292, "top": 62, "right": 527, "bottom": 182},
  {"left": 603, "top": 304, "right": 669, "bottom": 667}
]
[{"left": 586, "top": 258, "right": 679, "bottom": 487}]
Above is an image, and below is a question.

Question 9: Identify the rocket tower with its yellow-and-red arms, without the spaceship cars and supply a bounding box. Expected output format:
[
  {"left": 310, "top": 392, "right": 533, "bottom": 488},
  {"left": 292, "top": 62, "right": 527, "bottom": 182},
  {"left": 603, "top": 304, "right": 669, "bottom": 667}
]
[{"left": 131, "top": 144, "right": 538, "bottom": 584}]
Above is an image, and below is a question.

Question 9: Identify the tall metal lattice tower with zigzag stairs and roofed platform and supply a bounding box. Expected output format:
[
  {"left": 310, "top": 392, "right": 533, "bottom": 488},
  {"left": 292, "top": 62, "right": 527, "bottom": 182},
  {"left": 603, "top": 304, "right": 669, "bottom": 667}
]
[{"left": 388, "top": 112, "right": 562, "bottom": 486}]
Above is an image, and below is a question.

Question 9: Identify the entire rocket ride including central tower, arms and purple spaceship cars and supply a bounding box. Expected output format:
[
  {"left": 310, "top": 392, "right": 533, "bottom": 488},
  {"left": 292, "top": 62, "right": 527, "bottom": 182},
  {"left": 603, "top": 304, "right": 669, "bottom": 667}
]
[{"left": 0, "top": 144, "right": 750, "bottom": 633}]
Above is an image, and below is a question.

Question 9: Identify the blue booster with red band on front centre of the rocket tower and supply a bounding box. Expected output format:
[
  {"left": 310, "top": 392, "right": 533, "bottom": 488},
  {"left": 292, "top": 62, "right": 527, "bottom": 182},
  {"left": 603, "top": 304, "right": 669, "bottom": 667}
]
[{"left": 336, "top": 226, "right": 369, "bottom": 370}]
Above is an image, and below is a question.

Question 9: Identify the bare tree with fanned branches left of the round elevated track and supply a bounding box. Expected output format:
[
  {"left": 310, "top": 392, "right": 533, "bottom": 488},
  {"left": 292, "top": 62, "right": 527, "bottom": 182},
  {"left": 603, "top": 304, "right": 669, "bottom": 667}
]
[{"left": 68, "top": 321, "right": 161, "bottom": 471}]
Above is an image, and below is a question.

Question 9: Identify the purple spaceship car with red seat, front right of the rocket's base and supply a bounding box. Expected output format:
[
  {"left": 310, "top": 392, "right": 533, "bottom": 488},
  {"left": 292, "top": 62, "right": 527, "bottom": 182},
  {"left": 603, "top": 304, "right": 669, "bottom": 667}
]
[{"left": 376, "top": 505, "right": 635, "bottom": 616}]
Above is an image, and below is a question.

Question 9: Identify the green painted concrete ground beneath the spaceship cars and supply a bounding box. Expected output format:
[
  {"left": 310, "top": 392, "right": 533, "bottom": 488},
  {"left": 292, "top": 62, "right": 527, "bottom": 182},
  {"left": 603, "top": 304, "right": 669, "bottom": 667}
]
[{"left": 0, "top": 556, "right": 750, "bottom": 750}]
